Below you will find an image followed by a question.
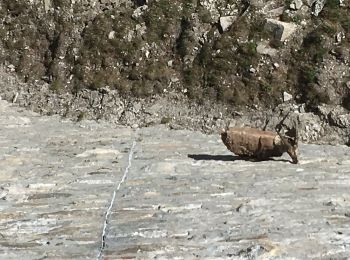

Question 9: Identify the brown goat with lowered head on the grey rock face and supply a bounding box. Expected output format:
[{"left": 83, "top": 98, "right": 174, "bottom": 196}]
[{"left": 221, "top": 127, "right": 298, "bottom": 163}]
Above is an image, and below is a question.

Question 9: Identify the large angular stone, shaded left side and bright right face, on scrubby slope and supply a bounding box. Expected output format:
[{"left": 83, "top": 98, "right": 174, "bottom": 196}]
[{"left": 265, "top": 19, "right": 298, "bottom": 42}]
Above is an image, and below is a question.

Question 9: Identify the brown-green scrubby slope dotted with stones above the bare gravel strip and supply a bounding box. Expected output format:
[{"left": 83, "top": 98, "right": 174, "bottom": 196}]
[{"left": 0, "top": 0, "right": 350, "bottom": 108}]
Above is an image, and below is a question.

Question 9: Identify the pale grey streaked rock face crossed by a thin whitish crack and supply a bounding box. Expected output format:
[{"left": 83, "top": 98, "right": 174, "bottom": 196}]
[{"left": 0, "top": 101, "right": 350, "bottom": 259}]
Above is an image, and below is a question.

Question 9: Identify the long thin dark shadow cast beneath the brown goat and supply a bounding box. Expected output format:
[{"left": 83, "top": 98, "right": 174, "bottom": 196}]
[{"left": 187, "top": 154, "right": 292, "bottom": 163}]
